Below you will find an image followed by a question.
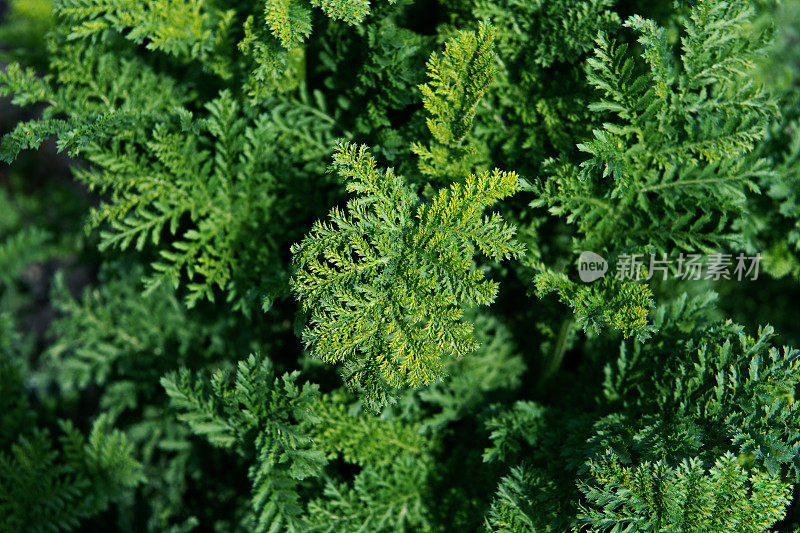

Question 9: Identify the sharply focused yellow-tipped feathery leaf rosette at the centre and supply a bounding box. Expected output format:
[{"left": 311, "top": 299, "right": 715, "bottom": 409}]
[{"left": 291, "top": 139, "right": 522, "bottom": 409}]
